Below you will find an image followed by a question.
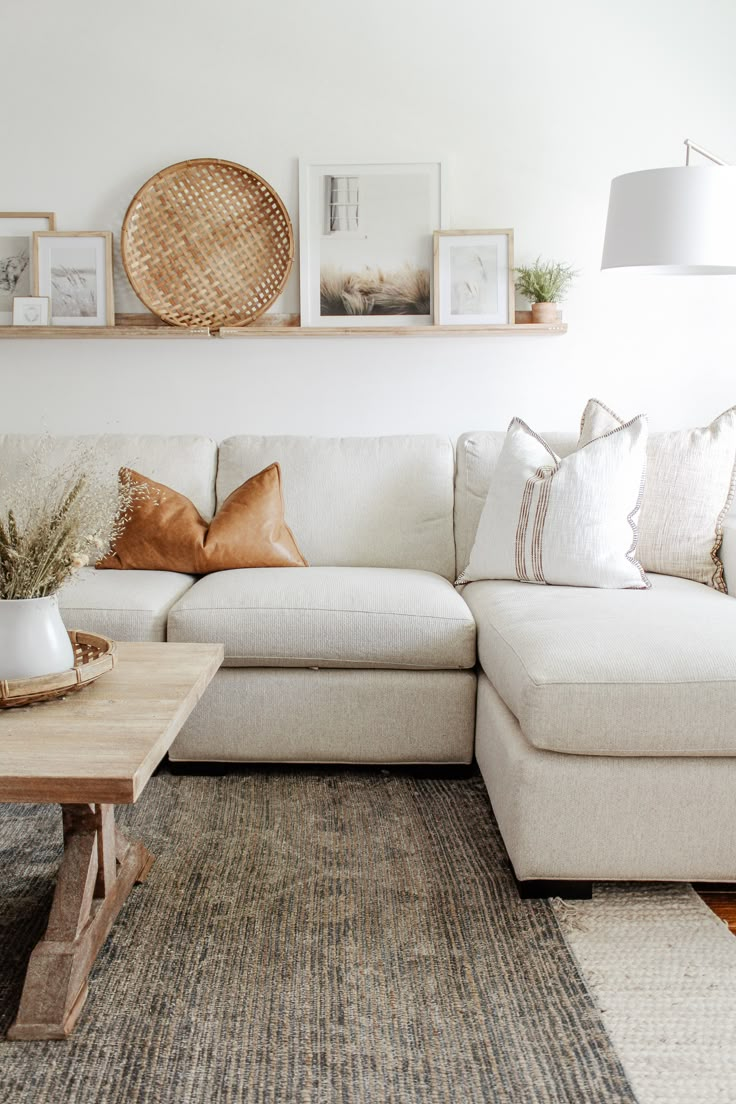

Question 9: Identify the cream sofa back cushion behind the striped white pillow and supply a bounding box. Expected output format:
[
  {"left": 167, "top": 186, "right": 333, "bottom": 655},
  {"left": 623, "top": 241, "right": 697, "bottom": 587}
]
[{"left": 455, "top": 431, "right": 578, "bottom": 575}]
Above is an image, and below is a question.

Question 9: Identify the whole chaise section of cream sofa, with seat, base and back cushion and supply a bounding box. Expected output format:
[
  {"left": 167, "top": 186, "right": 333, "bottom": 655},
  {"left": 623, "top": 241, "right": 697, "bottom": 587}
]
[{"left": 456, "top": 434, "right": 736, "bottom": 885}]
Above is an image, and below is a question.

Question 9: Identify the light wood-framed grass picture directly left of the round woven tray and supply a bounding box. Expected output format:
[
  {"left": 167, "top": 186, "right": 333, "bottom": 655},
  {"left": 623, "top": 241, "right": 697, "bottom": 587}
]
[{"left": 33, "top": 230, "right": 115, "bottom": 326}]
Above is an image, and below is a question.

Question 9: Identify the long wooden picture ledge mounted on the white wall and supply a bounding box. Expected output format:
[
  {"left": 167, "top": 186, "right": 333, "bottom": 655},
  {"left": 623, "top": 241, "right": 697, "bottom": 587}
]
[{"left": 0, "top": 310, "right": 567, "bottom": 341}]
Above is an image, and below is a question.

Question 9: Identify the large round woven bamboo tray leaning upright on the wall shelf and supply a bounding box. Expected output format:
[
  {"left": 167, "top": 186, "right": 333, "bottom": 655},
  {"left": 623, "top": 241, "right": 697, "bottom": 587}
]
[{"left": 120, "top": 158, "right": 294, "bottom": 329}]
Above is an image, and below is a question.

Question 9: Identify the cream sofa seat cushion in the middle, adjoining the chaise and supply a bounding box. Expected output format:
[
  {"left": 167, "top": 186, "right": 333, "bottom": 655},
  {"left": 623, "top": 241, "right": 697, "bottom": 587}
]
[{"left": 169, "top": 567, "right": 476, "bottom": 670}]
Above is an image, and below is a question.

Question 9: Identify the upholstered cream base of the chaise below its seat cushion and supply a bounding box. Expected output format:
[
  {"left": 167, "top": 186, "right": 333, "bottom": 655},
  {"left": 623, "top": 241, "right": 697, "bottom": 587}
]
[{"left": 476, "top": 666, "right": 736, "bottom": 895}]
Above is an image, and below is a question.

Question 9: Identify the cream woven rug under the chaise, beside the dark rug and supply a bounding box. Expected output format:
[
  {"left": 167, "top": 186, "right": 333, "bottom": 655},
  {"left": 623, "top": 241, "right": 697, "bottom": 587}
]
[{"left": 554, "top": 884, "right": 736, "bottom": 1104}]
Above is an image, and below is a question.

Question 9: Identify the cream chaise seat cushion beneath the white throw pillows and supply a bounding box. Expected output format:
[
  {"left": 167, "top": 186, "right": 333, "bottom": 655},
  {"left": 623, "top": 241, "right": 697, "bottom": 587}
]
[{"left": 463, "top": 575, "right": 736, "bottom": 755}]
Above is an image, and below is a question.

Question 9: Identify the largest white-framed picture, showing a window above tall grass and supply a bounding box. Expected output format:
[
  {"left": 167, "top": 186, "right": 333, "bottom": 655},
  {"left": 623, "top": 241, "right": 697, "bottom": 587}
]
[{"left": 299, "top": 159, "right": 447, "bottom": 329}]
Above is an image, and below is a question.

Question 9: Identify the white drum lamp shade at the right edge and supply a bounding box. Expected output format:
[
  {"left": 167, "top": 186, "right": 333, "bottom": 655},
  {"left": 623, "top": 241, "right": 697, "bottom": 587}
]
[{"left": 601, "top": 164, "right": 736, "bottom": 275}]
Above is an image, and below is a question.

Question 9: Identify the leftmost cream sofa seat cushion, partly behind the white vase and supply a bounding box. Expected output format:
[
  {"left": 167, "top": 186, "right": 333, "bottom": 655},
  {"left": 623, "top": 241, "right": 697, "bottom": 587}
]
[{"left": 58, "top": 567, "right": 195, "bottom": 640}]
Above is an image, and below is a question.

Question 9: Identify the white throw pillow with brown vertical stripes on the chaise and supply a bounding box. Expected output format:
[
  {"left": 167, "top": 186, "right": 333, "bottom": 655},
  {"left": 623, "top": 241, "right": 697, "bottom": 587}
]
[{"left": 458, "top": 415, "right": 649, "bottom": 590}]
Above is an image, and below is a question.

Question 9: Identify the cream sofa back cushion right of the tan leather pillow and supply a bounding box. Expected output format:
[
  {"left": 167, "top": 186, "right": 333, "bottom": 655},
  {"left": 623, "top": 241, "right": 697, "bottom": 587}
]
[{"left": 217, "top": 435, "right": 455, "bottom": 578}]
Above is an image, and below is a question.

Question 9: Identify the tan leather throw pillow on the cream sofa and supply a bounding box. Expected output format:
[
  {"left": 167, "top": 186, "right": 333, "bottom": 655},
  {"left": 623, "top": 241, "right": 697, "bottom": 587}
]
[{"left": 97, "top": 464, "right": 307, "bottom": 575}]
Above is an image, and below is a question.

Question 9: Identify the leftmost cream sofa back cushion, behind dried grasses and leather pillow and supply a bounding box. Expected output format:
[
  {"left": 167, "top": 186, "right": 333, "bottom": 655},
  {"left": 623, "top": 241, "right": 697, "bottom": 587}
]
[{"left": 0, "top": 434, "right": 217, "bottom": 521}]
